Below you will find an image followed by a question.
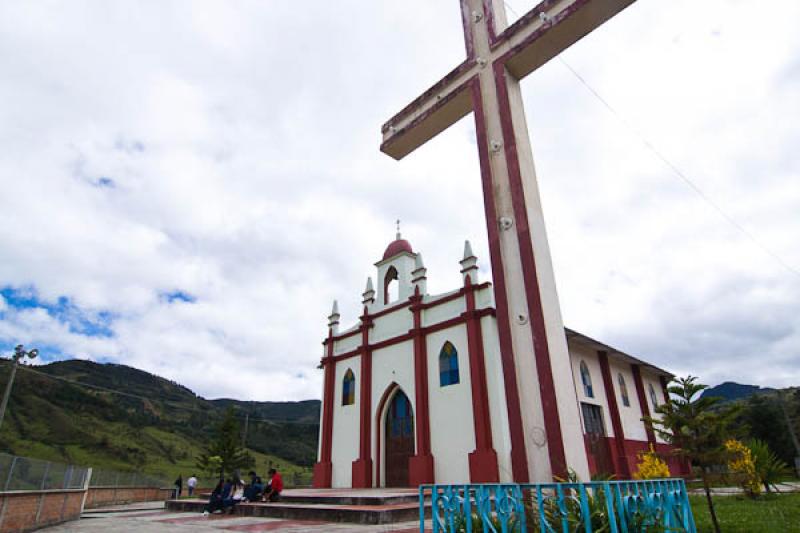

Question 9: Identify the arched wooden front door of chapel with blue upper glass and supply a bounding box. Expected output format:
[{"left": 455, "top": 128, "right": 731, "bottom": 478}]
[{"left": 384, "top": 390, "right": 414, "bottom": 487}]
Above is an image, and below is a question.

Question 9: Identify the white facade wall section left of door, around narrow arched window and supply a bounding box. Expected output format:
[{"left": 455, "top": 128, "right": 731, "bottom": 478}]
[{"left": 331, "top": 356, "right": 361, "bottom": 488}]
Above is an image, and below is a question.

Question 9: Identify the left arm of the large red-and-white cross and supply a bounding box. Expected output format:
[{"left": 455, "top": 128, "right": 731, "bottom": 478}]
[{"left": 381, "top": 60, "right": 475, "bottom": 159}]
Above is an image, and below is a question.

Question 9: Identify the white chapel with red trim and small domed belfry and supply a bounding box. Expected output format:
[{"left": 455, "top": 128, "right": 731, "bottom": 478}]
[{"left": 314, "top": 232, "right": 685, "bottom": 488}]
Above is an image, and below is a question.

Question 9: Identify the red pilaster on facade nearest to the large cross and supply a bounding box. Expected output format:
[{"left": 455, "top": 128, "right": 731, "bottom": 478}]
[{"left": 464, "top": 274, "right": 500, "bottom": 483}]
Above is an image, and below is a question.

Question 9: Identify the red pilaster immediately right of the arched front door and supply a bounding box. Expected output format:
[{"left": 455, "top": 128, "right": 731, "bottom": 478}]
[{"left": 408, "top": 287, "right": 434, "bottom": 487}]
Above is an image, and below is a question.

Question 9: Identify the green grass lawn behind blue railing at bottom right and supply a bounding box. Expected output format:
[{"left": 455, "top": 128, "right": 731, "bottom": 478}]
[{"left": 689, "top": 493, "right": 800, "bottom": 533}]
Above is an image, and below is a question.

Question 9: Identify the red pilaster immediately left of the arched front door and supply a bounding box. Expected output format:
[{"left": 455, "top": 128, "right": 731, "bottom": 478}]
[{"left": 353, "top": 306, "right": 372, "bottom": 489}]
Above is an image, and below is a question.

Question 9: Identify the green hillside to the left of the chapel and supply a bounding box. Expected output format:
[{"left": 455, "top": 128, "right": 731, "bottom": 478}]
[{"left": 0, "top": 360, "right": 320, "bottom": 480}]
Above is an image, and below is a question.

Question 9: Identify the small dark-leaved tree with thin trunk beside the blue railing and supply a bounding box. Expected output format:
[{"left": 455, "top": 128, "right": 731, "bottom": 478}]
[{"left": 645, "top": 376, "right": 739, "bottom": 533}]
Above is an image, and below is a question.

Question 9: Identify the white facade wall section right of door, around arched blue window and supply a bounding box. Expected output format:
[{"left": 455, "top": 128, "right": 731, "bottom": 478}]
[{"left": 425, "top": 325, "right": 475, "bottom": 483}]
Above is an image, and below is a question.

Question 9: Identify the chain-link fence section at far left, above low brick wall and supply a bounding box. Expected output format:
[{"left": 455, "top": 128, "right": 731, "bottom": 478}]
[{"left": 0, "top": 453, "right": 89, "bottom": 491}]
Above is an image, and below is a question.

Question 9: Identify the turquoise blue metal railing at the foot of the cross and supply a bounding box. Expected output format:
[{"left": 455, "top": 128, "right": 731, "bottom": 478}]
[{"left": 419, "top": 479, "right": 697, "bottom": 533}]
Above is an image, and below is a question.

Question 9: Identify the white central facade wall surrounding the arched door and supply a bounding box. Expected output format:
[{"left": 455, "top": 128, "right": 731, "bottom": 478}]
[{"left": 372, "top": 340, "right": 416, "bottom": 487}]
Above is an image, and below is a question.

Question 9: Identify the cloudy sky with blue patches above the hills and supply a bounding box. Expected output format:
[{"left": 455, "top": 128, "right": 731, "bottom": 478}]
[{"left": 0, "top": 0, "right": 800, "bottom": 400}]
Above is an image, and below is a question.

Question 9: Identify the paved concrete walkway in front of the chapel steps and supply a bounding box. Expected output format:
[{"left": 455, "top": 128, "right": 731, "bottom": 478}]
[{"left": 42, "top": 502, "right": 428, "bottom": 533}]
